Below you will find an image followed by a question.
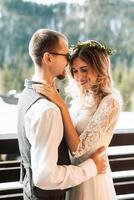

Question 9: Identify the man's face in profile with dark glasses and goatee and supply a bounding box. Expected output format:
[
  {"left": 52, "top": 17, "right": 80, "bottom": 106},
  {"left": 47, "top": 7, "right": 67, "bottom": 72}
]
[{"left": 48, "top": 38, "right": 69, "bottom": 79}]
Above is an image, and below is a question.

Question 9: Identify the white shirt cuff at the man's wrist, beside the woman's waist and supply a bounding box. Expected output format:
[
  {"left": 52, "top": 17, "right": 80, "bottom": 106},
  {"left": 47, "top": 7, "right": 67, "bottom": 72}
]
[{"left": 79, "top": 159, "right": 97, "bottom": 179}]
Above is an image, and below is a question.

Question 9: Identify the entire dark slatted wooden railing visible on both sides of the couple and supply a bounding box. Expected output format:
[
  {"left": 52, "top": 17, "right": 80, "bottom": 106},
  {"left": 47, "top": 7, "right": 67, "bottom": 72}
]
[{"left": 0, "top": 130, "right": 134, "bottom": 200}]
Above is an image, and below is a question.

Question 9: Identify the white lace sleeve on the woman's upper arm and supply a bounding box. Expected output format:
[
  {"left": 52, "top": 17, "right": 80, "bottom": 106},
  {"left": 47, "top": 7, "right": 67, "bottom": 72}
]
[{"left": 73, "top": 95, "right": 121, "bottom": 158}]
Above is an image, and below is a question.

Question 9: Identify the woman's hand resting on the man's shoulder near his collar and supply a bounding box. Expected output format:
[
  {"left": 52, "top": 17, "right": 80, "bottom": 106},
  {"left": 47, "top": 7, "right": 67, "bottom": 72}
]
[{"left": 33, "top": 83, "right": 65, "bottom": 108}]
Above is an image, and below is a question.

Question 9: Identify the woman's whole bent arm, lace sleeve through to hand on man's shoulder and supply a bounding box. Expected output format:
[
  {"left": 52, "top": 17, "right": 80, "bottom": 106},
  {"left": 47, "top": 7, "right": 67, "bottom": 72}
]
[{"left": 32, "top": 84, "right": 120, "bottom": 157}]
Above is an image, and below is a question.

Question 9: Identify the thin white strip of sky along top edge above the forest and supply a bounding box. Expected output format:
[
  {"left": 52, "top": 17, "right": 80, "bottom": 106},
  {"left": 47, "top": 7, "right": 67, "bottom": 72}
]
[{"left": 23, "top": 0, "right": 85, "bottom": 5}]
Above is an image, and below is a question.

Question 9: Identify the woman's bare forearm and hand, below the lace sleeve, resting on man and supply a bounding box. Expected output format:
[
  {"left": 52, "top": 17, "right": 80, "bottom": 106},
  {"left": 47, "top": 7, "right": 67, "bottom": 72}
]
[{"left": 34, "top": 84, "right": 80, "bottom": 154}]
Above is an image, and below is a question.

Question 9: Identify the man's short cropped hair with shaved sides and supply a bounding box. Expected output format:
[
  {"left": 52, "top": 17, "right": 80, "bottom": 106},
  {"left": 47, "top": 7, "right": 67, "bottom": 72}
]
[{"left": 29, "top": 29, "right": 68, "bottom": 66}]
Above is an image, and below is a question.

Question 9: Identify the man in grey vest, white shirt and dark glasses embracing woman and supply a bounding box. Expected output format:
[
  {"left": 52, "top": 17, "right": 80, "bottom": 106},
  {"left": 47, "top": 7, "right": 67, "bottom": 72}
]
[{"left": 18, "top": 29, "right": 106, "bottom": 200}]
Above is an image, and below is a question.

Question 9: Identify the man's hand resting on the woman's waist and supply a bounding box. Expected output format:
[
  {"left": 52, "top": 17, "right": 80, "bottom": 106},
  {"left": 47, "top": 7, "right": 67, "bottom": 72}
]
[{"left": 91, "top": 147, "right": 107, "bottom": 174}]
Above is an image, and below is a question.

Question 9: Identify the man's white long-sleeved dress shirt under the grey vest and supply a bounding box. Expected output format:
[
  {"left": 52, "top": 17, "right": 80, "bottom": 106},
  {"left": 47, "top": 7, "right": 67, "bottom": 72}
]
[{"left": 25, "top": 76, "right": 97, "bottom": 190}]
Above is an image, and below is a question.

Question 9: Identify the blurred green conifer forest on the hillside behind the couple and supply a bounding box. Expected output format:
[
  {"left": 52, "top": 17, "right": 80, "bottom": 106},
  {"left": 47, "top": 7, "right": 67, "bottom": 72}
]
[{"left": 0, "top": 0, "right": 134, "bottom": 111}]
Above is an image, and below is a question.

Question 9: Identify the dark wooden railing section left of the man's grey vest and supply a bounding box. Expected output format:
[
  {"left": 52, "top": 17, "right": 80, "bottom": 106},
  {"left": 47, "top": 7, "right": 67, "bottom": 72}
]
[{"left": 0, "top": 134, "right": 23, "bottom": 200}]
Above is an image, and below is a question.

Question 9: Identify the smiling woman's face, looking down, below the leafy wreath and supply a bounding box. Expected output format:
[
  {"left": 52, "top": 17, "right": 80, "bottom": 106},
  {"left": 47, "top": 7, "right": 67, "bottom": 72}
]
[{"left": 71, "top": 57, "right": 97, "bottom": 90}]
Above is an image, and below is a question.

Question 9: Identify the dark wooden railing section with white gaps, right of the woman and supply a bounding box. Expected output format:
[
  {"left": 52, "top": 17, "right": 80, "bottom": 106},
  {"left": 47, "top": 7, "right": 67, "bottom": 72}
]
[{"left": 108, "top": 130, "right": 134, "bottom": 200}]
